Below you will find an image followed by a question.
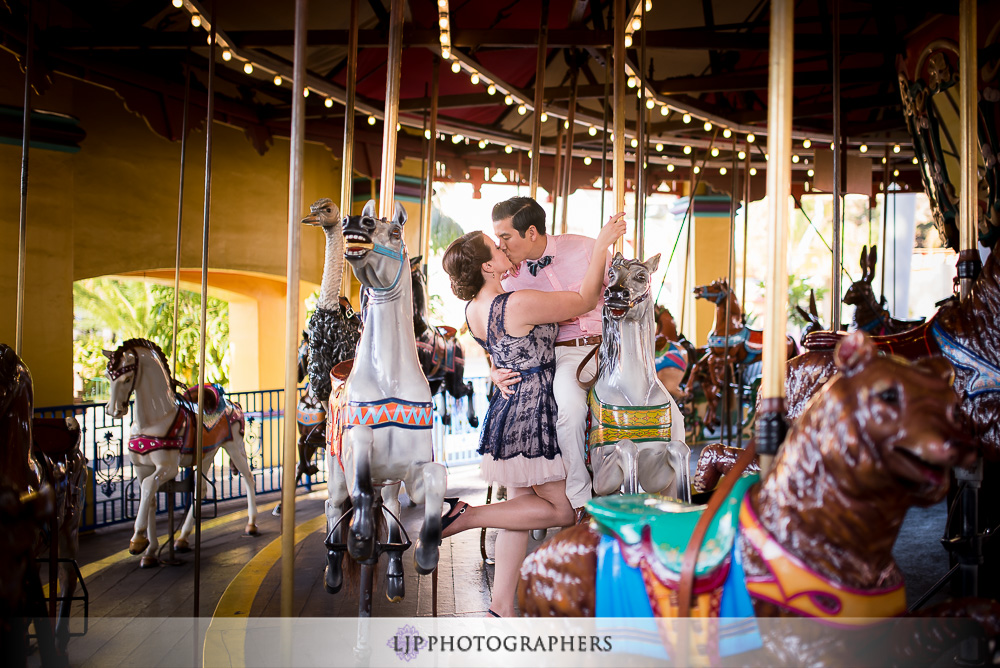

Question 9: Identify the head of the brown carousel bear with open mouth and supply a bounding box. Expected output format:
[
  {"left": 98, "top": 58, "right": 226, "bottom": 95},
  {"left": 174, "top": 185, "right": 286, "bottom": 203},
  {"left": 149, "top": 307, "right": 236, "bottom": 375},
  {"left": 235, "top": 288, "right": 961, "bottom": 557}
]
[{"left": 792, "top": 332, "right": 975, "bottom": 506}]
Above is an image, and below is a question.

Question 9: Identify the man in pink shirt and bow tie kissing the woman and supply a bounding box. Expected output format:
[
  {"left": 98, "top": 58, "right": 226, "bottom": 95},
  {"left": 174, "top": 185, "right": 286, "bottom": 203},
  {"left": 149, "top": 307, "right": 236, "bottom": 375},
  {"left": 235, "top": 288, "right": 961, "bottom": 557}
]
[{"left": 491, "top": 197, "right": 623, "bottom": 521}]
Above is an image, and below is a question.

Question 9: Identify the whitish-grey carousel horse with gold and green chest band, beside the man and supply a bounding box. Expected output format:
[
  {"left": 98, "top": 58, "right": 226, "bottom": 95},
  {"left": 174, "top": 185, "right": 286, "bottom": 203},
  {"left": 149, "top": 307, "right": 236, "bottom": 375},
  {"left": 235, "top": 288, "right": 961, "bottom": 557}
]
[{"left": 587, "top": 253, "right": 691, "bottom": 501}]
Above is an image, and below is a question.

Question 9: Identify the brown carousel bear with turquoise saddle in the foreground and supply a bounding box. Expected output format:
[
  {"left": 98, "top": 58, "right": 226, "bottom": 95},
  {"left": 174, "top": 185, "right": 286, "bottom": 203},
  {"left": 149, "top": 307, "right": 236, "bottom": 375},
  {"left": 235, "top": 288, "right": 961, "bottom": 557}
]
[{"left": 518, "top": 332, "right": 1000, "bottom": 665}]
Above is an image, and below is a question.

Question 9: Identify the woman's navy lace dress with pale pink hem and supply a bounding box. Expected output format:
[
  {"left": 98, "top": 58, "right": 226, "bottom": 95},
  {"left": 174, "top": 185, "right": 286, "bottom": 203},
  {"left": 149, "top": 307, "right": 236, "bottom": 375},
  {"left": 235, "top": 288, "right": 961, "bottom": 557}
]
[{"left": 466, "top": 292, "right": 566, "bottom": 487}]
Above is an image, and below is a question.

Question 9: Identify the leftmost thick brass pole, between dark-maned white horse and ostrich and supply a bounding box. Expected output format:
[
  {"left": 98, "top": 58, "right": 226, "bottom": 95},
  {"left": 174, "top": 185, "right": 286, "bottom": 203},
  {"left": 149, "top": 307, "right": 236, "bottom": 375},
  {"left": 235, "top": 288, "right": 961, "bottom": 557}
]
[{"left": 281, "top": 0, "right": 306, "bottom": 617}]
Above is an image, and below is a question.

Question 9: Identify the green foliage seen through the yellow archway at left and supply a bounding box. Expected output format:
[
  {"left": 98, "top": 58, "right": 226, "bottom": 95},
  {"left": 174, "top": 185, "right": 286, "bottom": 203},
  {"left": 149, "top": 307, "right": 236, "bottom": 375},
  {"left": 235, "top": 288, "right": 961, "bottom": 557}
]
[{"left": 73, "top": 278, "right": 229, "bottom": 397}]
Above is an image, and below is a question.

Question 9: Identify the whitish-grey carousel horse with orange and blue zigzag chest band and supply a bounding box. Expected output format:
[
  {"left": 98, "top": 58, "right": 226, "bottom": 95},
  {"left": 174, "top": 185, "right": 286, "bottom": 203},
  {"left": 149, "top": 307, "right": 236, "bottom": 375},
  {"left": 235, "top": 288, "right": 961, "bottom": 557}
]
[{"left": 326, "top": 200, "right": 447, "bottom": 600}]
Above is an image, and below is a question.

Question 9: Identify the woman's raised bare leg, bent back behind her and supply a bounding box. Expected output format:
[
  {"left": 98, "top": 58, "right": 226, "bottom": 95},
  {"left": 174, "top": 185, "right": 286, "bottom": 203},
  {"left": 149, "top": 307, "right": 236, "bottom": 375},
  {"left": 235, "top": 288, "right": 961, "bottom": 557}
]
[{"left": 442, "top": 480, "right": 576, "bottom": 540}]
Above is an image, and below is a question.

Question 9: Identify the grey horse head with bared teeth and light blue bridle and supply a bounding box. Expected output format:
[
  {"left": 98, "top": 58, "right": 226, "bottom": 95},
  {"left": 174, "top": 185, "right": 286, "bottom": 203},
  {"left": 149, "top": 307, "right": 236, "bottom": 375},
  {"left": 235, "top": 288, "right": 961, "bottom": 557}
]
[{"left": 343, "top": 200, "right": 406, "bottom": 291}]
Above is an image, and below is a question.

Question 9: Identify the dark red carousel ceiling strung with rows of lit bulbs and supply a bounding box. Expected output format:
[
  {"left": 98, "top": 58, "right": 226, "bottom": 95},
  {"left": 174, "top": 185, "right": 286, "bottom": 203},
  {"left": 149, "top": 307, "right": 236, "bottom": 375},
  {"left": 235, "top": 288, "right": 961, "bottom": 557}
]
[{"left": 0, "top": 0, "right": 958, "bottom": 196}]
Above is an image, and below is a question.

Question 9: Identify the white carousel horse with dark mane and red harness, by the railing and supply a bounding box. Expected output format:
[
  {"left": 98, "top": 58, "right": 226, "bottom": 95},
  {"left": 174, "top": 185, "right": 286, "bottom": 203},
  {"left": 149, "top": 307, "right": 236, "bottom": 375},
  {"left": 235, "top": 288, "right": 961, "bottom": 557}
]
[{"left": 103, "top": 339, "right": 257, "bottom": 568}]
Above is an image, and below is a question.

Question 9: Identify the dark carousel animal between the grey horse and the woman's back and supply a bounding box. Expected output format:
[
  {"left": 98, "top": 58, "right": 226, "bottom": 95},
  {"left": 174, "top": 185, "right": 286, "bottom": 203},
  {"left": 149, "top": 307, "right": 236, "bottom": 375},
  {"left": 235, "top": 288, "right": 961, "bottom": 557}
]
[{"left": 410, "top": 255, "right": 479, "bottom": 429}]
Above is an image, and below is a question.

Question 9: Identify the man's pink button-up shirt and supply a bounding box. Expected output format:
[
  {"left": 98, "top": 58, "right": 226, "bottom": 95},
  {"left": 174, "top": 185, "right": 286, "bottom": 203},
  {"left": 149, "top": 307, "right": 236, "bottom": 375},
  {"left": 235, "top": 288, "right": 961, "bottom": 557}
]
[{"left": 501, "top": 234, "right": 610, "bottom": 341}]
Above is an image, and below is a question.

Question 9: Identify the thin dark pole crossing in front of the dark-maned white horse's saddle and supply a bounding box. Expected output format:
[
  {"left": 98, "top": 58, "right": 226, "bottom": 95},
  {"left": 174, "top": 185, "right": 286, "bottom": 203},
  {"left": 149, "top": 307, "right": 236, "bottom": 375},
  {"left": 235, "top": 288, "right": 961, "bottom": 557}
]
[{"left": 192, "top": 5, "right": 218, "bottom": 617}]
